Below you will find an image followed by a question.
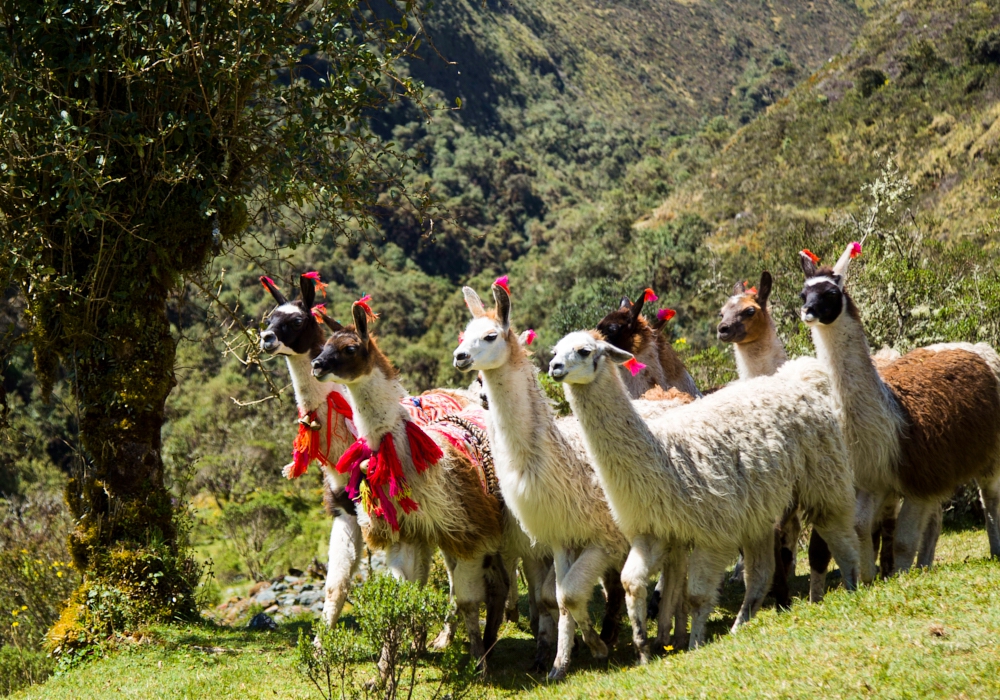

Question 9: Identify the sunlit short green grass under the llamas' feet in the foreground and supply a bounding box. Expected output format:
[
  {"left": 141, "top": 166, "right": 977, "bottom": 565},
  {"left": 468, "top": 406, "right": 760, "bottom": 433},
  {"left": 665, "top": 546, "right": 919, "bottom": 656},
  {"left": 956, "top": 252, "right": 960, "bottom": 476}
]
[{"left": 15, "top": 528, "right": 1000, "bottom": 700}]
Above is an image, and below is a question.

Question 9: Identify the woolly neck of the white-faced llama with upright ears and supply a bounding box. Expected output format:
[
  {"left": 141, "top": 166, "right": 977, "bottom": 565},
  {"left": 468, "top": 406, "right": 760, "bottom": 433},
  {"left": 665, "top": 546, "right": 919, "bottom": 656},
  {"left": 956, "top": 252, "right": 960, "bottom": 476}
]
[{"left": 483, "top": 355, "right": 557, "bottom": 471}]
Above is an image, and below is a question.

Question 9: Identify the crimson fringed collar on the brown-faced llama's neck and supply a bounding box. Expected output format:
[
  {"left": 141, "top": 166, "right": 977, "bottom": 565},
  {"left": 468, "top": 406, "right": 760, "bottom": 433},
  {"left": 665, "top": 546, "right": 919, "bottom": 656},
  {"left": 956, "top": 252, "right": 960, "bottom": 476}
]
[{"left": 336, "top": 421, "right": 444, "bottom": 531}]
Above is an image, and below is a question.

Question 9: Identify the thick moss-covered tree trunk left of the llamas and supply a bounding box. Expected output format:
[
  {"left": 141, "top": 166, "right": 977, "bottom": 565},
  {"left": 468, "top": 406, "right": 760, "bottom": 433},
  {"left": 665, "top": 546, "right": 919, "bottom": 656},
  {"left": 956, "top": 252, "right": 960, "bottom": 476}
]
[{"left": 51, "top": 288, "right": 199, "bottom": 648}]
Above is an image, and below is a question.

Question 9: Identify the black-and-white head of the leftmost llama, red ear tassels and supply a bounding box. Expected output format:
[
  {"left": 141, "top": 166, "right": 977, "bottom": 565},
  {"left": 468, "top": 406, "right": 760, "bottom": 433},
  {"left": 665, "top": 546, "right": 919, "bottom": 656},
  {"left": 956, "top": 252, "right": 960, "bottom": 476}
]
[{"left": 260, "top": 275, "right": 323, "bottom": 357}]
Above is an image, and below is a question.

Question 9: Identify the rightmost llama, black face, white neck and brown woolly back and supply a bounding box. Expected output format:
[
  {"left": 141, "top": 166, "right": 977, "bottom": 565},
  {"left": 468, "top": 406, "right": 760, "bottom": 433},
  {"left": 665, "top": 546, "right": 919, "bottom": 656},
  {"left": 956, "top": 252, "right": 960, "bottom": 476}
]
[{"left": 800, "top": 243, "right": 1000, "bottom": 582}]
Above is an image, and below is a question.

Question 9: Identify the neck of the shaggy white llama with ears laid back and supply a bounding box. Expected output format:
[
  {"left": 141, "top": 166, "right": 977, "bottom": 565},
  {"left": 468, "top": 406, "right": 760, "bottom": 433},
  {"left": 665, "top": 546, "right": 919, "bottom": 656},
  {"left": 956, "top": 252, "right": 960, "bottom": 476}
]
[{"left": 564, "top": 362, "right": 687, "bottom": 537}]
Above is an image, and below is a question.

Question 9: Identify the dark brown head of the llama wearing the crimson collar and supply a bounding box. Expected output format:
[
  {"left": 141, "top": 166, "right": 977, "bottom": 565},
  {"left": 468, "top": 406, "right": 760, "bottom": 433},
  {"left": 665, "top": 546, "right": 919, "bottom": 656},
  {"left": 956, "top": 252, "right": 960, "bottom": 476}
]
[{"left": 312, "top": 302, "right": 397, "bottom": 384}]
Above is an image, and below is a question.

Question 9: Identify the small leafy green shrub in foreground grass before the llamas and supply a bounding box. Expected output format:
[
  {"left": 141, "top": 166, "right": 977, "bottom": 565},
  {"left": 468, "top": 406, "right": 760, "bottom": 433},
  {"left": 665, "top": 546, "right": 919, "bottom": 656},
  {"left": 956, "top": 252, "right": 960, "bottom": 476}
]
[{"left": 298, "top": 574, "right": 476, "bottom": 700}]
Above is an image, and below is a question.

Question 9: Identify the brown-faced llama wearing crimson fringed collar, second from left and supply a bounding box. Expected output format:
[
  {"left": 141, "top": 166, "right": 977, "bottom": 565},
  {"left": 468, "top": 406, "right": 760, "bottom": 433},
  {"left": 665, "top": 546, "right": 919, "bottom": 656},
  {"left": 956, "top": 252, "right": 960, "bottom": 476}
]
[{"left": 312, "top": 299, "right": 542, "bottom": 664}]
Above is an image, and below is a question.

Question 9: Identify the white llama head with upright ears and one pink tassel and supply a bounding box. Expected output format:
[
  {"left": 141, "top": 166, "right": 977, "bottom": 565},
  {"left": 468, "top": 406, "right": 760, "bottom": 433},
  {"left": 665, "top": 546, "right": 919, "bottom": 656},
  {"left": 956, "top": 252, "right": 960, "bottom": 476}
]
[{"left": 453, "top": 284, "right": 520, "bottom": 372}]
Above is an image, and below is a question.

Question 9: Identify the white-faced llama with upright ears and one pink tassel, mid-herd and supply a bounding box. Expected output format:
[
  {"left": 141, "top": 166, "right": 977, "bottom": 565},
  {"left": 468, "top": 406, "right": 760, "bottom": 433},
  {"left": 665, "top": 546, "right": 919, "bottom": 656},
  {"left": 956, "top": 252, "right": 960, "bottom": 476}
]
[{"left": 454, "top": 278, "right": 640, "bottom": 680}]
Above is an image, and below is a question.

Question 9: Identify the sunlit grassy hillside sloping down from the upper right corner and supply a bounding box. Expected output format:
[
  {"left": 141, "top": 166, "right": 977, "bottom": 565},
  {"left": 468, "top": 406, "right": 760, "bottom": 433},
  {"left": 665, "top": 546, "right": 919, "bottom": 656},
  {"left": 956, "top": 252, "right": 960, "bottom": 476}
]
[{"left": 647, "top": 0, "right": 1000, "bottom": 246}]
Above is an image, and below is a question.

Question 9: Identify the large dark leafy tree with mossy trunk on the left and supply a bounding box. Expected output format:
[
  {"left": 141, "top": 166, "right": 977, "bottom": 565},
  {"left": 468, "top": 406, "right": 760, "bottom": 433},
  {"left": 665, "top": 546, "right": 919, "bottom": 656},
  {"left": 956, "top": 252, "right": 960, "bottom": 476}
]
[{"left": 0, "top": 0, "right": 421, "bottom": 644}]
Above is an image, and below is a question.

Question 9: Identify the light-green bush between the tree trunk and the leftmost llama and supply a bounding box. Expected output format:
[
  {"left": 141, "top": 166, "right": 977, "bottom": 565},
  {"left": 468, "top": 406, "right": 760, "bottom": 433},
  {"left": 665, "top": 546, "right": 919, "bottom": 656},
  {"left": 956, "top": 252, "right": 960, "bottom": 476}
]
[{"left": 222, "top": 493, "right": 302, "bottom": 581}]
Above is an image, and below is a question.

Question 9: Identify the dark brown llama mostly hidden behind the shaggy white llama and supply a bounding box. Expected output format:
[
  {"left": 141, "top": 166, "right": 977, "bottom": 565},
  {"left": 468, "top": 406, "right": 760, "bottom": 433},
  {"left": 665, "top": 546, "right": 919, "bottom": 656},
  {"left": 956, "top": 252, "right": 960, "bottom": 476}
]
[{"left": 597, "top": 289, "right": 701, "bottom": 399}]
